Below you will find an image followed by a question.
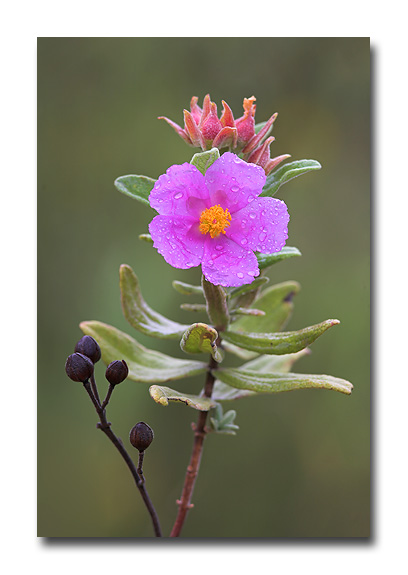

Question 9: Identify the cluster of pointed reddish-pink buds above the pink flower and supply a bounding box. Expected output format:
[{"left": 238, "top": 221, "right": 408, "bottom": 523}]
[{"left": 159, "top": 94, "right": 290, "bottom": 175}]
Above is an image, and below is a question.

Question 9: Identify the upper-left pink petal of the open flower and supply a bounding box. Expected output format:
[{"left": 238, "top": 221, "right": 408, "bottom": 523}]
[{"left": 149, "top": 162, "right": 210, "bottom": 221}]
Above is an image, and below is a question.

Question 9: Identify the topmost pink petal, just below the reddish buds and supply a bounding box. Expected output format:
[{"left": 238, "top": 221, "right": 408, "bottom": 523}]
[{"left": 205, "top": 152, "right": 266, "bottom": 214}]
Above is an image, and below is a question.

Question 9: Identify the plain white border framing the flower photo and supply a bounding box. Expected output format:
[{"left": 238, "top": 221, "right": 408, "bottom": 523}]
[{"left": 0, "top": 0, "right": 408, "bottom": 575}]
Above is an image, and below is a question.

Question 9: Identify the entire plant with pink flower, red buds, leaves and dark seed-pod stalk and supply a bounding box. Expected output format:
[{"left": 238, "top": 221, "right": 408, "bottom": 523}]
[{"left": 66, "top": 95, "right": 352, "bottom": 537}]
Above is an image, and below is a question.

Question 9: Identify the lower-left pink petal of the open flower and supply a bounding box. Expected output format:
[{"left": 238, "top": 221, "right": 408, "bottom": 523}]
[{"left": 149, "top": 216, "right": 204, "bottom": 269}]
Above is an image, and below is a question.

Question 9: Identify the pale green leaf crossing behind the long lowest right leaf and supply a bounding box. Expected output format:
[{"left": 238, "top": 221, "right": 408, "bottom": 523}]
[{"left": 212, "top": 347, "right": 310, "bottom": 401}]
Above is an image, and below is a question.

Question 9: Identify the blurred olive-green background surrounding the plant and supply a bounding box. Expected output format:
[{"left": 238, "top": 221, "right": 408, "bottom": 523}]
[{"left": 38, "top": 38, "right": 370, "bottom": 538}]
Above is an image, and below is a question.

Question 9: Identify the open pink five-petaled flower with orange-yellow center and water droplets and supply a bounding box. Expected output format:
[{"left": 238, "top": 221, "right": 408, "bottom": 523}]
[{"left": 149, "top": 152, "right": 289, "bottom": 287}]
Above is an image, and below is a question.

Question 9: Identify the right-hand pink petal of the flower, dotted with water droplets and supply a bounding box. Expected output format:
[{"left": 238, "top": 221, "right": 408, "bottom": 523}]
[{"left": 226, "top": 198, "right": 289, "bottom": 254}]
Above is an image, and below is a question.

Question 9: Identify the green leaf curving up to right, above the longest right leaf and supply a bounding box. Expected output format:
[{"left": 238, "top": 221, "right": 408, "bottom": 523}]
[{"left": 223, "top": 318, "right": 340, "bottom": 355}]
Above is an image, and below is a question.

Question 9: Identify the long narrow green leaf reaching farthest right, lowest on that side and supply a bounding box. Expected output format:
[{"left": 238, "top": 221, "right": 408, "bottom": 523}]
[{"left": 214, "top": 368, "right": 353, "bottom": 395}]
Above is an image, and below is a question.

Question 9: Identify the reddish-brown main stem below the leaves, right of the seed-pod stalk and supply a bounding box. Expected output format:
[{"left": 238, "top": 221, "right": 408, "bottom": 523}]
[{"left": 170, "top": 357, "right": 217, "bottom": 537}]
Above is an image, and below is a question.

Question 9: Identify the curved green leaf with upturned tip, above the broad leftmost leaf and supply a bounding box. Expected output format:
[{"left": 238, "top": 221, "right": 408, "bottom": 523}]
[{"left": 119, "top": 265, "right": 188, "bottom": 339}]
